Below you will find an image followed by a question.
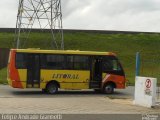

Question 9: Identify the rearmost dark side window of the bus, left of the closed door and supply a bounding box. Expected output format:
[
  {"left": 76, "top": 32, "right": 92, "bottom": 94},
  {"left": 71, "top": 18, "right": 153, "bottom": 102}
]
[{"left": 16, "top": 53, "right": 27, "bottom": 69}]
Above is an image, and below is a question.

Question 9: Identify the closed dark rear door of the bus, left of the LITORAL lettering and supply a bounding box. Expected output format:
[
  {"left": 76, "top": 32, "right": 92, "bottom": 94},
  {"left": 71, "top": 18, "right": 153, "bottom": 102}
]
[{"left": 27, "top": 54, "right": 40, "bottom": 88}]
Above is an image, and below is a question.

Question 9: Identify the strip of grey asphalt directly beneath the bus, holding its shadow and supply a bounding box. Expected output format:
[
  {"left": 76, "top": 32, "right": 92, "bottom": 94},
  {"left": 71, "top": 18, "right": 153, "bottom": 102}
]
[{"left": 0, "top": 85, "right": 134, "bottom": 99}]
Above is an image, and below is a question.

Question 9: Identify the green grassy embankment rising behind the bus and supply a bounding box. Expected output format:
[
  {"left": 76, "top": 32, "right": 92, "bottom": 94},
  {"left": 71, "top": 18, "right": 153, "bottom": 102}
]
[{"left": 0, "top": 32, "right": 160, "bottom": 84}]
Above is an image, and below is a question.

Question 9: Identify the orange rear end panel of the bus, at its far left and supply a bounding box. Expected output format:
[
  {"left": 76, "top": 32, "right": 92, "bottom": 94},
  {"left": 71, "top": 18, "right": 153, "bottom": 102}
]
[{"left": 8, "top": 50, "right": 23, "bottom": 88}]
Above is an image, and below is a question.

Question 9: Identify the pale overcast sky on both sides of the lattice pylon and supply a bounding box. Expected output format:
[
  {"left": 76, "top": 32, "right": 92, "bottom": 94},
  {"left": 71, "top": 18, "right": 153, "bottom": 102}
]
[{"left": 0, "top": 0, "right": 160, "bottom": 32}]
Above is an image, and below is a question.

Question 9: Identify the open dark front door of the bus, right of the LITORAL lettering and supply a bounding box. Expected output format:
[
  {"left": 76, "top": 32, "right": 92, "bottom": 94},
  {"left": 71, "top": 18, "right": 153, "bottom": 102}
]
[{"left": 90, "top": 58, "right": 102, "bottom": 89}]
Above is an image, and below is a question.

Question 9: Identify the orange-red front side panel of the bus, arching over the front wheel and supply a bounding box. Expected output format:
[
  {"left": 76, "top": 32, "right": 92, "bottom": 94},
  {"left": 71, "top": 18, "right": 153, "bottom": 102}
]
[{"left": 102, "top": 73, "right": 126, "bottom": 89}]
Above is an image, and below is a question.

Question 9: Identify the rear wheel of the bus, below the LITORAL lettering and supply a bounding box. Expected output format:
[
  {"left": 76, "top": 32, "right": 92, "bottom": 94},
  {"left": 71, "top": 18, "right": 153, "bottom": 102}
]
[{"left": 46, "top": 82, "right": 58, "bottom": 94}]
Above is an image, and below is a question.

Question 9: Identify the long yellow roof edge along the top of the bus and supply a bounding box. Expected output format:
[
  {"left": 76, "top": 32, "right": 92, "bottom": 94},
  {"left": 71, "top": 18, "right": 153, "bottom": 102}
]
[{"left": 12, "top": 49, "right": 116, "bottom": 56}]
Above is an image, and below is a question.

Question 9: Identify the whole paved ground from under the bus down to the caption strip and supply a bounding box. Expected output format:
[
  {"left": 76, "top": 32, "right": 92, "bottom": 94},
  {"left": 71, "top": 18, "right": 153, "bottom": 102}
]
[{"left": 0, "top": 86, "right": 160, "bottom": 114}]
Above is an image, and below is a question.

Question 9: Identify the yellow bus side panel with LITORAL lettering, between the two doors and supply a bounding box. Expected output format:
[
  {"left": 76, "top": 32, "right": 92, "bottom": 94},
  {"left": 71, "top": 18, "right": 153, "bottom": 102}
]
[{"left": 41, "top": 70, "right": 90, "bottom": 89}]
